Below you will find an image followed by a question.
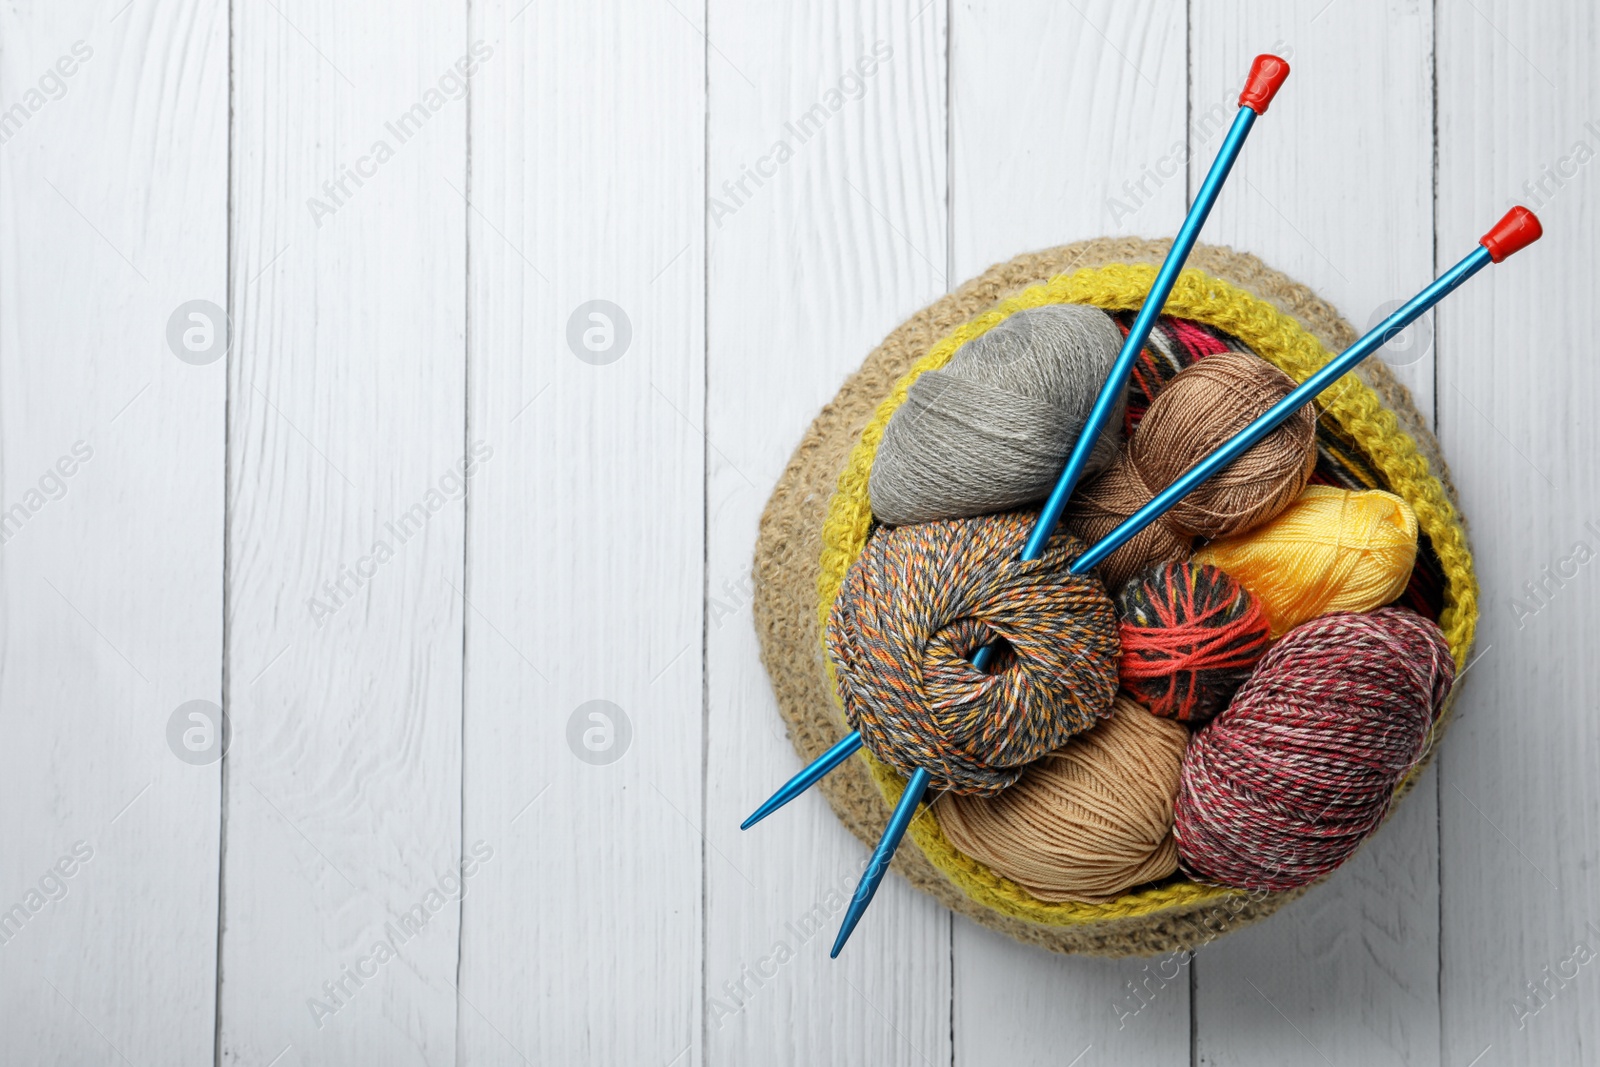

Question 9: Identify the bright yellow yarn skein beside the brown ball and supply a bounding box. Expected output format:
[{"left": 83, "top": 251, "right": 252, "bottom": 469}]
[{"left": 1195, "top": 485, "right": 1416, "bottom": 637}]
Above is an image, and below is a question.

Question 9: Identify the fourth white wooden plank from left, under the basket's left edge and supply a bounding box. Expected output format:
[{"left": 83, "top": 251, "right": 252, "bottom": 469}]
[{"left": 706, "top": 2, "right": 950, "bottom": 1064}]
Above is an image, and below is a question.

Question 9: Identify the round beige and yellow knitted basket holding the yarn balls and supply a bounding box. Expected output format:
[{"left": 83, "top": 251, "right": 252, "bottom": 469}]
[{"left": 754, "top": 238, "right": 1478, "bottom": 957}]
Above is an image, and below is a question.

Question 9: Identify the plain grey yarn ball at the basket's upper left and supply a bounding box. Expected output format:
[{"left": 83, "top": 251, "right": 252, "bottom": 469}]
[{"left": 869, "top": 304, "right": 1122, "bottom": 525}]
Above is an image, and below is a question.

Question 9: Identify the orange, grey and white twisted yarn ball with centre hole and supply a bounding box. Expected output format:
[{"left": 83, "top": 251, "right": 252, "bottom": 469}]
[{"left": 824, "top": 512, "right": 1118, "bottom": 795}]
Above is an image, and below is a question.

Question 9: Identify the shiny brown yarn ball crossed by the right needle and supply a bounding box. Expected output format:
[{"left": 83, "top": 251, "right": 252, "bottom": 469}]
[{"left": 1066, "top": 352, "right": 1317, "bottom": 589}]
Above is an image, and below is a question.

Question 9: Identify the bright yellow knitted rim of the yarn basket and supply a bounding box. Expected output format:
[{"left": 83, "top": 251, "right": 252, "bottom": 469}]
[{"left": 818, "top": 264, "right": 1478, "bottom": 926}]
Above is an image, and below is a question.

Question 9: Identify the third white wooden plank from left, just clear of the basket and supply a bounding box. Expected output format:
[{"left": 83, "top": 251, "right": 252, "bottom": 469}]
[{"left": 461, "top": 0, "right": 722, "bottom": 1065}]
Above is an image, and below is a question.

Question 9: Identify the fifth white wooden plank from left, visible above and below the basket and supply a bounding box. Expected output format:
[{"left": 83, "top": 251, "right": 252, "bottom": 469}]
[{"left": 950, "top": 3, "right": 1189, "bottom": 1065}]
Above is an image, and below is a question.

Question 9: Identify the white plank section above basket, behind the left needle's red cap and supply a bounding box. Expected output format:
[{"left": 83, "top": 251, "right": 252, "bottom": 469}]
[{"left": 1189, "top": 0, "right": 1434, "bottom": 418}]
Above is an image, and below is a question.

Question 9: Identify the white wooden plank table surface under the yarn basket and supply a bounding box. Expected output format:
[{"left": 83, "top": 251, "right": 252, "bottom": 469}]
[{"left": 0, "top": 0, "right": 1600, "bottom": 1067}]
